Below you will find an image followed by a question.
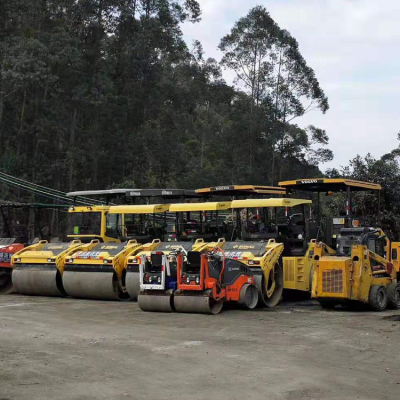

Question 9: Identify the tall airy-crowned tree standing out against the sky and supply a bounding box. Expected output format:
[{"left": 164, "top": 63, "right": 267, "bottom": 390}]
[{"left": 219, "top": 6, "right": 329, "bottom": 181}]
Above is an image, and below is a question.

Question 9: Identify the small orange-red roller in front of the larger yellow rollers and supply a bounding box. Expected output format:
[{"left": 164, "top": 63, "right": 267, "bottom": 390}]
[{"left": 174, "top": 248, "right": 258, "bottom": 314}]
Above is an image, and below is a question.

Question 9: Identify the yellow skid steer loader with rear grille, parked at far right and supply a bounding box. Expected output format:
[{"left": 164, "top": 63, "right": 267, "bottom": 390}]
[{"left": 312, "top": 228, "right": 400, "bottom": 311}]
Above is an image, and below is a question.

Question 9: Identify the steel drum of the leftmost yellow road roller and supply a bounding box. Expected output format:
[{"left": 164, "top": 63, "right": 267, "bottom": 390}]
[{"left": 12, "top": 265, "right": 65, "bottom": 296}]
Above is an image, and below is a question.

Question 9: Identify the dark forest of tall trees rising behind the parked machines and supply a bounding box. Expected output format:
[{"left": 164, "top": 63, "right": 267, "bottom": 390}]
[{"left": 0, "top": 0, "right": 332, "bottom": 199}]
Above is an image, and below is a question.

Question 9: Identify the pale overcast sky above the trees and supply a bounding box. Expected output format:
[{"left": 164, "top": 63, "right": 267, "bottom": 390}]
[{"left": 182, "top": 0, "right": 400, "bottom": 170}]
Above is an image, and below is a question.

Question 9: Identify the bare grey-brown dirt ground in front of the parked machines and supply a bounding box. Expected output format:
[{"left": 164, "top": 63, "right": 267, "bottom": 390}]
[{"left": 0, "top": 295, "right": 400, "bottom": 400}]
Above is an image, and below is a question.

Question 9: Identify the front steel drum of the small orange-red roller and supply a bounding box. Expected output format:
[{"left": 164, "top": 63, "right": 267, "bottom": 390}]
[{"left": 174, "top": 294, "right": 224, "bottom": 315}]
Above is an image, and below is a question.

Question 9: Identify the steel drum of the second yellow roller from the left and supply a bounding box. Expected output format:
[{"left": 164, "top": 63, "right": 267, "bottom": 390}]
[{"left": 63, "top": 270, "right": 123, "bottom": 300}]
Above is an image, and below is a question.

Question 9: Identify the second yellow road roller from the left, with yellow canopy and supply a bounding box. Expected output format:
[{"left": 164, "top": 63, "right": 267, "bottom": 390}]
[{"left": 59, "top": 204, "right": 169, "bottom": 300}]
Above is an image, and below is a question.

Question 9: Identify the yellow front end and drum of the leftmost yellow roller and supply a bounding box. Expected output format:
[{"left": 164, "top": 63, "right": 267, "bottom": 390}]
[{"left": 11, "top": 240, "right": 82, "bottom": 296}]
